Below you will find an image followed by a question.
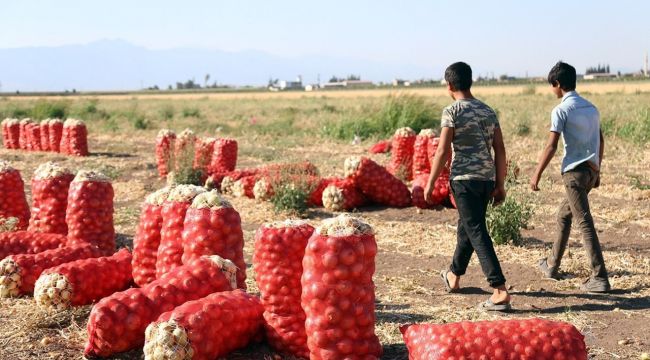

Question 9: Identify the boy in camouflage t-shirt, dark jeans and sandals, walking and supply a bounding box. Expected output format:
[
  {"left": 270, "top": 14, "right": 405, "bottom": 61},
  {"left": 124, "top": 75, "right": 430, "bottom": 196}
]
[{"left": 425, "top": 62, "right": 511, "bottom": 311}]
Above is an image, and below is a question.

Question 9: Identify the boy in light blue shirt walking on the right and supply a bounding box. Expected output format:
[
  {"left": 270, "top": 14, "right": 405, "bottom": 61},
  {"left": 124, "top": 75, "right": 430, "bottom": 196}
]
[{"left": 530, "top": 61, "right": 611, "bottom": 293}]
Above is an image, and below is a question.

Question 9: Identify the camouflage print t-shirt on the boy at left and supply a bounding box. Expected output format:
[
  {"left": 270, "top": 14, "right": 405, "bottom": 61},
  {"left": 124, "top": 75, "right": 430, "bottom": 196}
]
[{"left": 440, "top": 99, "right": 499, "bottom": 181}]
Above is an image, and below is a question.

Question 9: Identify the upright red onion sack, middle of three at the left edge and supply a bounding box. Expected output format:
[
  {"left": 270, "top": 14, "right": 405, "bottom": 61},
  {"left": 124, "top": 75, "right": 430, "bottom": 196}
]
[{"left": 28, "top": 162, "right": 74, "bottom": 235}]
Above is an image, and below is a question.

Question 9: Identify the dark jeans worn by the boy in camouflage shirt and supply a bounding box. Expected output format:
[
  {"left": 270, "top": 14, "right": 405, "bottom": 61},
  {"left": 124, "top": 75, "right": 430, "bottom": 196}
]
[{"left": 449, "top": 180, "right": 506, "bottom": 288}]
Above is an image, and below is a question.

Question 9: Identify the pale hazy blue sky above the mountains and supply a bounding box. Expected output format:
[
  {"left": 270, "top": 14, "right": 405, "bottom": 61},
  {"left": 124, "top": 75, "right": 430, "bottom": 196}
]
[{"left": 0, "top": 0, "right": 650, "bottom": 77}]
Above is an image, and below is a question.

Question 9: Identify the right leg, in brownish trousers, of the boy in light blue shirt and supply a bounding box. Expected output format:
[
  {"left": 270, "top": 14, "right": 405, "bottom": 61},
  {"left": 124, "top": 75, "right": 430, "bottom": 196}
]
[{"left": 562, "top": 169, "right": 609, "bottom": 283}]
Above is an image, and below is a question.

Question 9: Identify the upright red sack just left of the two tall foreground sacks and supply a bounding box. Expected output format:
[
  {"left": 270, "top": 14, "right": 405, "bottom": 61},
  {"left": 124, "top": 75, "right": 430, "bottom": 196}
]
[{"left": 181, "top": 190, "right": 246, "bottom": 289}]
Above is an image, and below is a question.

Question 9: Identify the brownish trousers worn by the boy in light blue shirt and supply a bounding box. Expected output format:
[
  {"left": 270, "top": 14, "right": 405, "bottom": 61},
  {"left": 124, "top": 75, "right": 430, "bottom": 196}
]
[{"left": 547, "top": 163, "right": 608, "bottom": 280}]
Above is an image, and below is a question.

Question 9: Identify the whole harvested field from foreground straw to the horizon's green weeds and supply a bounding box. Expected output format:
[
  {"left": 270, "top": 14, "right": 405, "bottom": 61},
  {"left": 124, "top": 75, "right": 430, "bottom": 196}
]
[{"left": 0, "top": 83, "right": 650, "bottom": 360}]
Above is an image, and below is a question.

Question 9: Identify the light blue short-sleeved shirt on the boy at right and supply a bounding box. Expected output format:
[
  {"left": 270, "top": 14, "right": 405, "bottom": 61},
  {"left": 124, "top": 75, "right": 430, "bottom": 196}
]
[{"left": 551, "top": 91, "right": 600, "bottom": 173}]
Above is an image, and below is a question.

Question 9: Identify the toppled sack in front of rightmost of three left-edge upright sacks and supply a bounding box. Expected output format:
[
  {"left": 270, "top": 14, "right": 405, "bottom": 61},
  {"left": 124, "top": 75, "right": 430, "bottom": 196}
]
[{"left": 34, "top": 249, "right": 133, "bottom": 309}]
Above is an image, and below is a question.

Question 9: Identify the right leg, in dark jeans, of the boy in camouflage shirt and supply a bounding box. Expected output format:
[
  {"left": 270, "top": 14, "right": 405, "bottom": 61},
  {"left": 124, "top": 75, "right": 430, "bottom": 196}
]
[{"left": 454, "top": 180, "right": 506, "bottom": 288}]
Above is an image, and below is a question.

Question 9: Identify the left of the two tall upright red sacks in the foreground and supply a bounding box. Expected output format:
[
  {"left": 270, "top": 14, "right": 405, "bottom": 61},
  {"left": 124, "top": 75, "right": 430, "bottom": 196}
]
[{"left": 253, "top": 220, "right": 314, "bottom": 358}]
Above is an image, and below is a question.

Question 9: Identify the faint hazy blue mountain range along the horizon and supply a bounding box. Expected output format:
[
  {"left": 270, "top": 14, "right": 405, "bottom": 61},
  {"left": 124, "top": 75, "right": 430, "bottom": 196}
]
[{"left": 0, "top": 40, "right": 436, "bottom": 92}]
